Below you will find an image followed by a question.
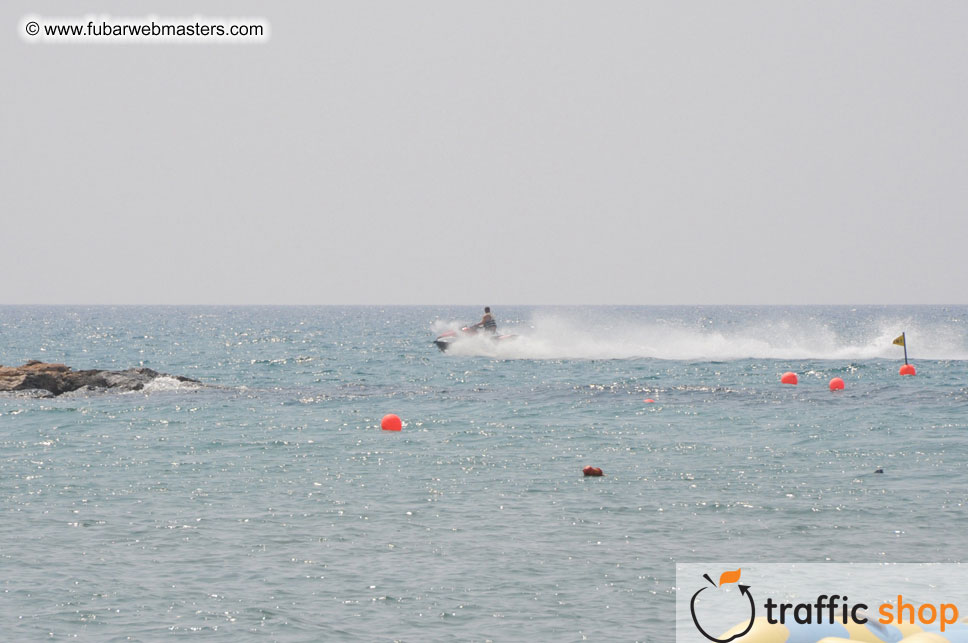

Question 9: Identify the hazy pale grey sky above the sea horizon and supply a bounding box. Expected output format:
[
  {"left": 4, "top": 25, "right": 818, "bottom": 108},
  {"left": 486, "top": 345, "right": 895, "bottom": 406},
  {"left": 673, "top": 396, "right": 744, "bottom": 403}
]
[{"left": 0, "top": 0, "right": 968, "bottom": 305}]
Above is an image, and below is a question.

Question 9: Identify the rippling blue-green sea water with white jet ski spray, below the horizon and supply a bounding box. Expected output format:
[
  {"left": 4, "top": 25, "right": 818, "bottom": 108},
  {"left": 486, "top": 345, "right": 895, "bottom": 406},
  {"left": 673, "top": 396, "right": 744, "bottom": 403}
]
[{"left": 0, "top": 306, "right": 968, "bottom": 641}]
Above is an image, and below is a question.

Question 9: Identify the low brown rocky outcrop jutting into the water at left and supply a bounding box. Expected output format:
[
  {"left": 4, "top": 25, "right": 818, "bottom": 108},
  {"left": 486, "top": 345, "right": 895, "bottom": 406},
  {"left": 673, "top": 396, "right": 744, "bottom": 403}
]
[{"left": 0, "top": 360, "right": 200, "bottom": 395}]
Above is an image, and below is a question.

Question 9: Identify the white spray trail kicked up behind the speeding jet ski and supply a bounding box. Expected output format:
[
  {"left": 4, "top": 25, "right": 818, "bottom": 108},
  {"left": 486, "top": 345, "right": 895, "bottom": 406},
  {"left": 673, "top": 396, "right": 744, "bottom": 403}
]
[{"left": 435, "top": 315, "right": 968, "bottom": 361}]
